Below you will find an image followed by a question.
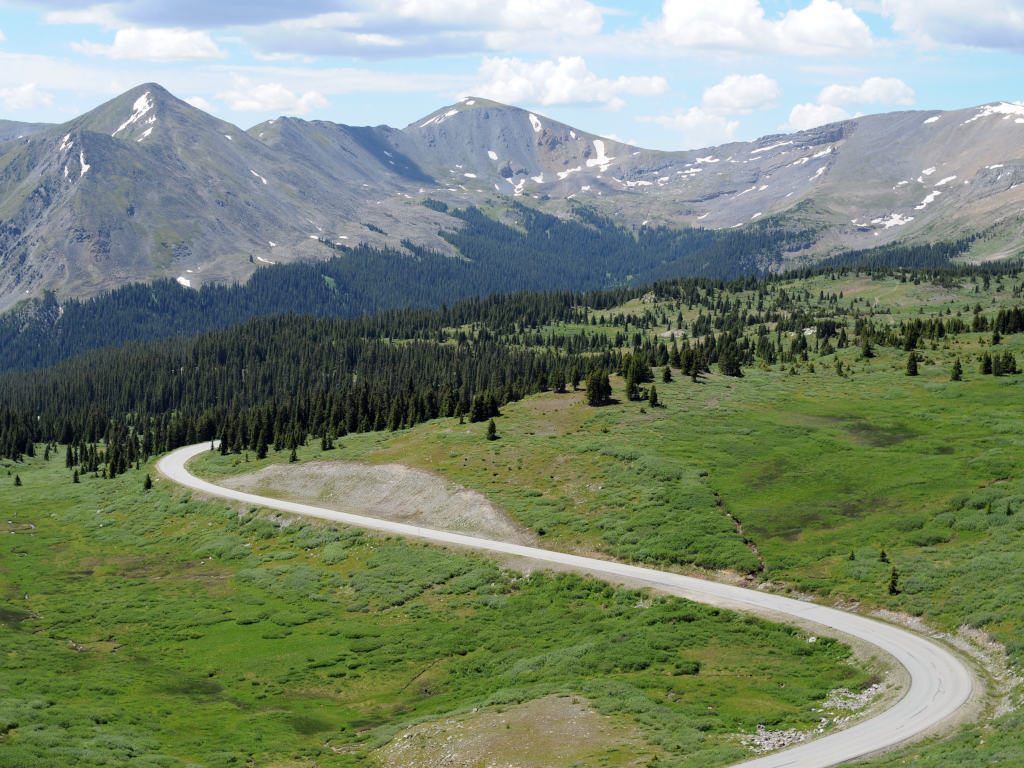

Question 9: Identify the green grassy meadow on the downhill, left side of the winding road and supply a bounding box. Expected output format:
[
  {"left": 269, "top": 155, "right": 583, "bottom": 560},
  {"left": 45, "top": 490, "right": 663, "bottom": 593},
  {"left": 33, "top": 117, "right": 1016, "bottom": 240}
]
[{"left": 0, "top": 450, "right": 872, "bottom": 768}]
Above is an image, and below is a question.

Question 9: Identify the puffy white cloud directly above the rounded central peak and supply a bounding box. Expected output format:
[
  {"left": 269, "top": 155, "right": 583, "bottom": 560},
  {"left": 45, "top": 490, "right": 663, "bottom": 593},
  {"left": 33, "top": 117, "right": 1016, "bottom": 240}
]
[{"left": 475, "top": 56, "right": 669, "bottom": 110}]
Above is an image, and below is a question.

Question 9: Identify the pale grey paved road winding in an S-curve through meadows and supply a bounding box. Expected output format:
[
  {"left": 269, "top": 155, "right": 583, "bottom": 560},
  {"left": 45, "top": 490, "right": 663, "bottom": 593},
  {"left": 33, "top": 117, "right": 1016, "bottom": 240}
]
[{"left": 157, "top": 443, "right": 974, "bottom": 768}]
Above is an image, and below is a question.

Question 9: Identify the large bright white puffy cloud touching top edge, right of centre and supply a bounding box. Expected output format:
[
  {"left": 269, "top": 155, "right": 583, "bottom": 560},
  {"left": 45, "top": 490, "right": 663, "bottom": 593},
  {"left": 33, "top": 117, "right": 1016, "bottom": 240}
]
[{"left": 647, "top": 0, "right": 871, "bottom": 56}]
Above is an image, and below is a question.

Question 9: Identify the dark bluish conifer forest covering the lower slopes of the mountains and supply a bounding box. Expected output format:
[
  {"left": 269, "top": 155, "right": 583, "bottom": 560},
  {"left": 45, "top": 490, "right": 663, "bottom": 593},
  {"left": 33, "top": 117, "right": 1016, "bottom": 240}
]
[{"left": 0, "top": 205, "right": 807, "bottom": 371}]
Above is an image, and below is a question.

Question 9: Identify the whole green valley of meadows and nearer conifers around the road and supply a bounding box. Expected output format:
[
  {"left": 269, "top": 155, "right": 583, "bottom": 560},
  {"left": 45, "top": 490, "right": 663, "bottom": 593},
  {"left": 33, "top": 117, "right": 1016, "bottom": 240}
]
[{"left": 0, "top": 267, "right": 1024, "bottom": 766}]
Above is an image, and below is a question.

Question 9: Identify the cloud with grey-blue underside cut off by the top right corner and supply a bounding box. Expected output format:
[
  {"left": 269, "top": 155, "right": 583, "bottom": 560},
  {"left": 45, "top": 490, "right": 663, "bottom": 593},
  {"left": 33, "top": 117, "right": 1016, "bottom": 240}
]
[{"left": 881, "top": 0, "right": 1024, "bottom": 52}]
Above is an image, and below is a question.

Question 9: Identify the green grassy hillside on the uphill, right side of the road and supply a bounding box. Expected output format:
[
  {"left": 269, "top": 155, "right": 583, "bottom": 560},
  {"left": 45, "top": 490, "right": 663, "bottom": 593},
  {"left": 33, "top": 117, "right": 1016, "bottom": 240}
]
[{"left": 192, "top": 274, "right": 1024, "bottom": 765}]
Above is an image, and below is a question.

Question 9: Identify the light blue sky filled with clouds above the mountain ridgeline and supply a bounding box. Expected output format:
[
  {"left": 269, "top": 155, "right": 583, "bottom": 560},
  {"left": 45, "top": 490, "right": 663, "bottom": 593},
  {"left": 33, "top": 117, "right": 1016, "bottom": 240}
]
[{"left": 0, "top": 0, "right": 1024, "bottom": 150}]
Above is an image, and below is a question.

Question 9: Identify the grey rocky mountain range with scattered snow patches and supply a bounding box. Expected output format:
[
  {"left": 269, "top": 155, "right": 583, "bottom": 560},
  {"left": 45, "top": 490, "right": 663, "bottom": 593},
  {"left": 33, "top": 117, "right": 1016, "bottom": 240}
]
[{"left": 0, "top": 83, "right": 1024, "bottom": 309}]
